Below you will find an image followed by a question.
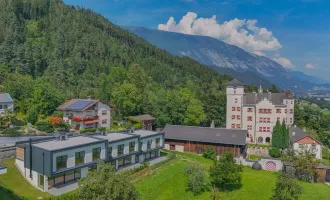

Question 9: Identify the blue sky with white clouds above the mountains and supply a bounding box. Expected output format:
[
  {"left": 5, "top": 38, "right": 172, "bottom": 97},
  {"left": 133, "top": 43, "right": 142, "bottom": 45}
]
[{"left": 64, "top": 0, "right": 330, "bottom": 80}]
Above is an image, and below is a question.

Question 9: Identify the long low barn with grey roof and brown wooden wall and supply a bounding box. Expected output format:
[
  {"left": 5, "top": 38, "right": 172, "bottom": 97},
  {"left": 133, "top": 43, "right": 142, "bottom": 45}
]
[{"left": 163, "top": 125, "right": 248, "bottom": 157}]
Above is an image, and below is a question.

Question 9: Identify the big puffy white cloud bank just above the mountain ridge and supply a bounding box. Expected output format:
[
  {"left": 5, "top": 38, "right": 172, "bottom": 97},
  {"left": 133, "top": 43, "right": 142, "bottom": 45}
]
[{"left": 158, "top": 12, "right": 282, "bottom": 52}]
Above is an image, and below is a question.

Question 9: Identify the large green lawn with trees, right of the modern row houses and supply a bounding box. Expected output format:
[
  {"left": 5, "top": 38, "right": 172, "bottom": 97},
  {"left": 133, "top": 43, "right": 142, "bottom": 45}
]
[{"left": 135, "top": 153, "right": 330, "bottom": 200}]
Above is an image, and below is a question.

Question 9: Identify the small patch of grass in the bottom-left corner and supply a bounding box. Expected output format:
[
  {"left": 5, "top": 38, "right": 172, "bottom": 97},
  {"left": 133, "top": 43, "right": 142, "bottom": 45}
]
[{"left": 0, "top": 159, "right": 51, "bottom": 200}]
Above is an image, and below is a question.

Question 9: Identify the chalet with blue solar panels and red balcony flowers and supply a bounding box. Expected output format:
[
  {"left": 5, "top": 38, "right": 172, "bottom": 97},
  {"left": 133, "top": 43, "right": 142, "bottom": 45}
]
[{"left": 57, "top": 99, "right": 111, "bottom": 130}]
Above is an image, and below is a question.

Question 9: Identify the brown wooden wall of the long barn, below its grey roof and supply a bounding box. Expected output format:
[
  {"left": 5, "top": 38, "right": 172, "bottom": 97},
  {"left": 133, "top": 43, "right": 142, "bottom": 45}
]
[{"left": 165, "top": 139, "right": 245, "bottom": 157}]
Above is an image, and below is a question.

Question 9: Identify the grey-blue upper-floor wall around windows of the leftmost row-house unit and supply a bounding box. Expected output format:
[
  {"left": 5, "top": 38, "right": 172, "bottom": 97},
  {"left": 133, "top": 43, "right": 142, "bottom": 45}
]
[{"left": 53, "top": 143, "right": 105, "bottom": 172}]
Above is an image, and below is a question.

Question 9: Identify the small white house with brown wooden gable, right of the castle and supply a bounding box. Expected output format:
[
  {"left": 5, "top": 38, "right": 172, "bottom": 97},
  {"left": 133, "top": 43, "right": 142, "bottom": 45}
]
[{"left": 290, "top": 126, "right": 322, "bottom": 159}]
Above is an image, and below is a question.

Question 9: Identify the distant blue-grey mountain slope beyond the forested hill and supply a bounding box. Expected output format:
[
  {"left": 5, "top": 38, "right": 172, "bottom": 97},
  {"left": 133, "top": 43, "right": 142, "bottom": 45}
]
[{"left": 122, "top": 26, "right": 314, "bottom": 90}]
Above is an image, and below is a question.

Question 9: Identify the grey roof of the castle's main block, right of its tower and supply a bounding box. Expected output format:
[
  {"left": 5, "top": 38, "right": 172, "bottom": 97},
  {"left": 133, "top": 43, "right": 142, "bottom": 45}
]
[{"left": 243, "top": 93, "right": 292, "bottom": 105}]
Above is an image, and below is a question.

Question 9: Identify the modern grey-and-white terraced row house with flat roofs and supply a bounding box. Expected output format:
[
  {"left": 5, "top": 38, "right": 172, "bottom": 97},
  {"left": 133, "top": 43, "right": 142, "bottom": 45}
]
[{"left": 15, "top": 130, "right": 164, "bottom": 191}]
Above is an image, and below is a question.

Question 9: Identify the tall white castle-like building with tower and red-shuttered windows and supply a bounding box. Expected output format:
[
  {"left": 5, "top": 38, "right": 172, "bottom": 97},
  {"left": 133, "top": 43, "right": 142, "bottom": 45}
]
[{"left": 226, "top": 79, "right": 294, "bottom": 143}]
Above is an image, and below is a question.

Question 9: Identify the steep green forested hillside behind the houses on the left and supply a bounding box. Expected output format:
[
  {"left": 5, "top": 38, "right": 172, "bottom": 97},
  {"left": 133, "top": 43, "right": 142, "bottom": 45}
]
[{"left": 0, "top": 0, "right": 240, "bottom": 126}]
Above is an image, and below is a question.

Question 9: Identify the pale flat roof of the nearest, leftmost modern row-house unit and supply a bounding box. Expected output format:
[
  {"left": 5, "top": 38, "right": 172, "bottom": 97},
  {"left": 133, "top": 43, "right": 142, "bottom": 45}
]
[{"left": 32, "top": 136, "right": 102, "bottom": 151}]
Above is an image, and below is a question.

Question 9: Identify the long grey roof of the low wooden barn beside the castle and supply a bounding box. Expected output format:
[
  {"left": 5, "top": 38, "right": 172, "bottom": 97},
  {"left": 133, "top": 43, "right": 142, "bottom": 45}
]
[{"left": 163, "top": 125, "right": 248, "bottom": 145}]
